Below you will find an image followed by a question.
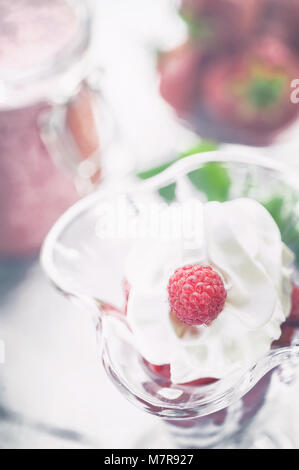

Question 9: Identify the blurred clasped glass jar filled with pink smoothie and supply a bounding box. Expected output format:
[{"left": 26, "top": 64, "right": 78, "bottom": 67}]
[{"left": 0, "top": 0, "right": 101, "bottom": 258}]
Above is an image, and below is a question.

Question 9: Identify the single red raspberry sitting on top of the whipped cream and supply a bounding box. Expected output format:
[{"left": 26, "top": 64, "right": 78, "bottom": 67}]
[{"left": 168, "top": 264, "right": 227, "bottom": 326}]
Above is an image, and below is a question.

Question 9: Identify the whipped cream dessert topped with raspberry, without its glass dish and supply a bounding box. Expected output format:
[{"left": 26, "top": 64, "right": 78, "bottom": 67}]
[{"left": 125, "top": 198, "right": 298, "bottom": 427}]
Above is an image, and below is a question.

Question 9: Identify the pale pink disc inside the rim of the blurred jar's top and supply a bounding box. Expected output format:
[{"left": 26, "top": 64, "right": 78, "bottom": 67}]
[{"left": 0, "top": 0, "right": 78, "bottom": 73}]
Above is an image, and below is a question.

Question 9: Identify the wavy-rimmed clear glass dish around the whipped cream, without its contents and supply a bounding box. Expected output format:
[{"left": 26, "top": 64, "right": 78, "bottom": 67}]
[{"left": 41, "top": 152, "right": 299, "bottom": 448}]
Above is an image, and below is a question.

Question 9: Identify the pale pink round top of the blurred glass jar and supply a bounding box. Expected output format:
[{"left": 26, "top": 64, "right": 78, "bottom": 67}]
[{"left": 0, "top": 0, "right": 91, "bottom": 108}]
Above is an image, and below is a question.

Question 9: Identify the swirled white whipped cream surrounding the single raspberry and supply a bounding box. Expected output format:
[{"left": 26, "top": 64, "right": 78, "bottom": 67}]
[{"left": 126, "top": 199, "right": 293, "bottom": 383}]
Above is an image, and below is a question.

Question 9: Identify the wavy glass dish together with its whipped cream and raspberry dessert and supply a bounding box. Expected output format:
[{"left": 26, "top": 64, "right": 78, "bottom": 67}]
[{"left": 41, "top": 151, "right": 299, "bottom": 448}]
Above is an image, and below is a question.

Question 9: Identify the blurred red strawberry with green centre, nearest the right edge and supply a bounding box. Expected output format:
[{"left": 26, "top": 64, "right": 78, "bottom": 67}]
[{"left": 198, "top": 37, "right": 299, "bottom": 145}]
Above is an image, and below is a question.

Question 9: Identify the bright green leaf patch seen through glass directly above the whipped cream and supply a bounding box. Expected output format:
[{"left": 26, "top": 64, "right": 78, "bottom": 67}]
[{"left": 188, "top": 162, "right": 231, "bottom": 202}]
